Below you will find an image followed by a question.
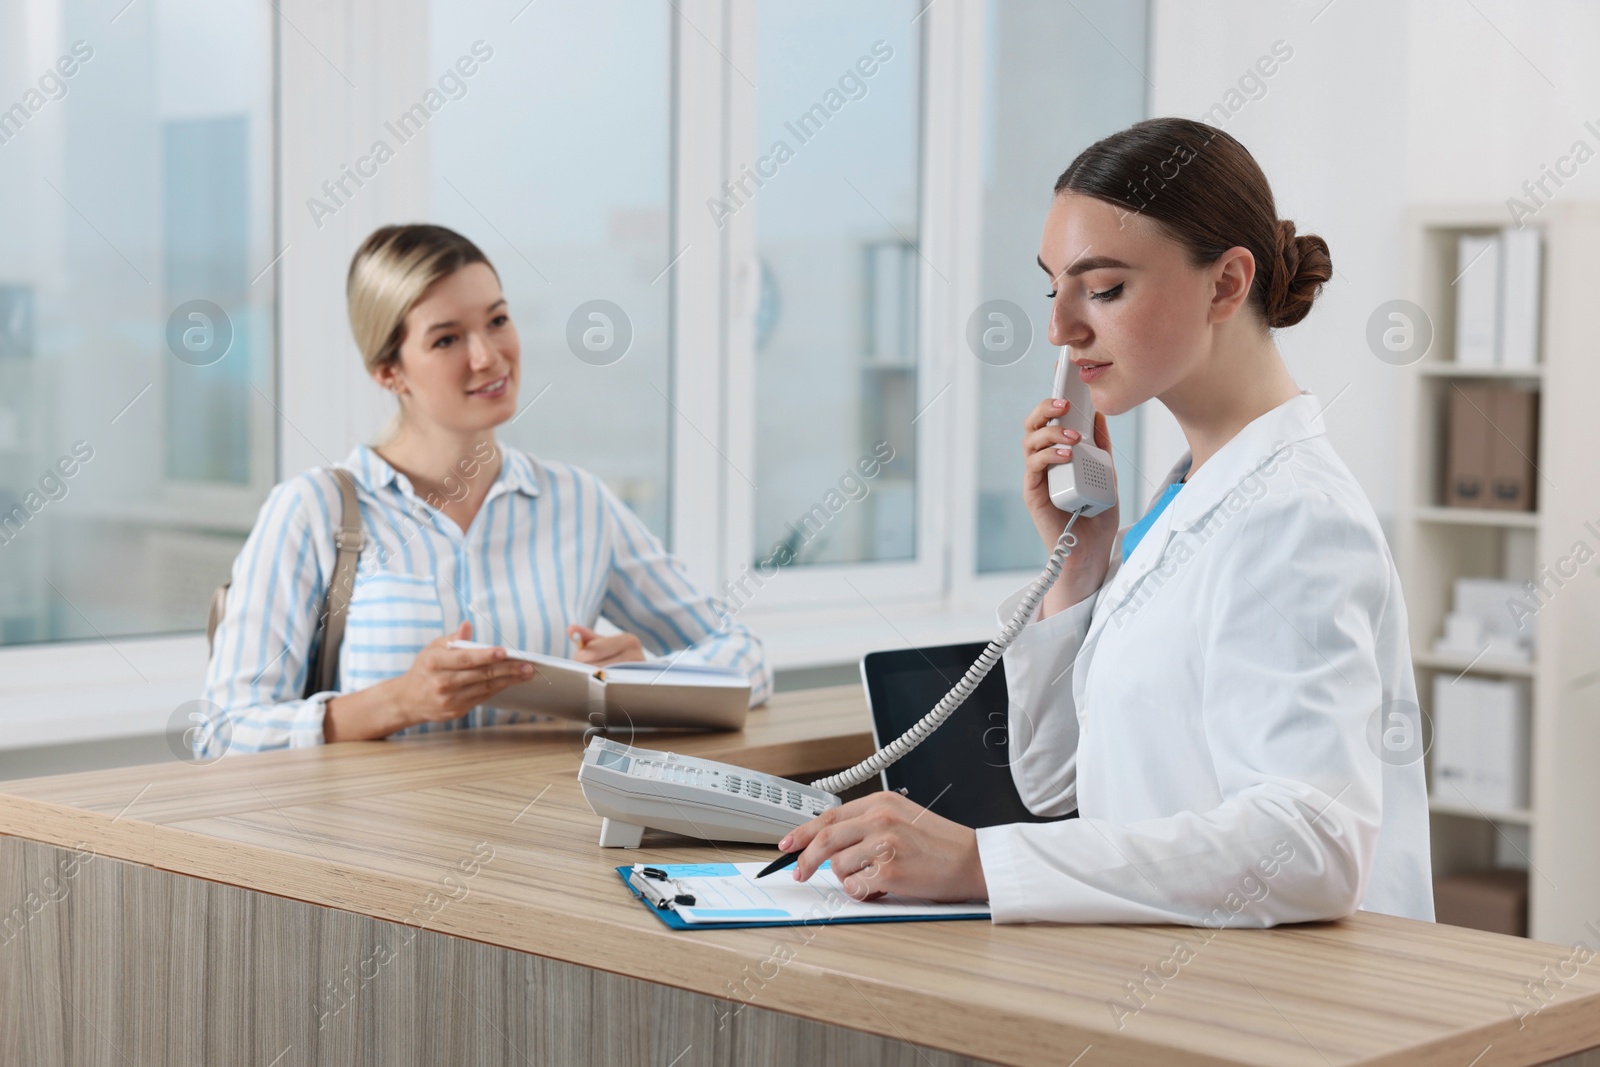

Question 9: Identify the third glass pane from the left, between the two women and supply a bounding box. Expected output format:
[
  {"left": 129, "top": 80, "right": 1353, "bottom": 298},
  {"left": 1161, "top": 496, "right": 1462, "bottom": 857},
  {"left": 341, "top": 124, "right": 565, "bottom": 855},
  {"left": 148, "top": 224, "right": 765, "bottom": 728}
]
[{"left": 752, "top": 0, "right": 925, "bottom": 572}]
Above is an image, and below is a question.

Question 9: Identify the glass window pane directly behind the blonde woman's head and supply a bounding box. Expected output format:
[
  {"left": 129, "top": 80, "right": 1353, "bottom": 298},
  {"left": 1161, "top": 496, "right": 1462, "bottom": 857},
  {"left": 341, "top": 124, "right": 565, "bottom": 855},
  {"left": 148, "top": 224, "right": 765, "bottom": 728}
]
[{"left": 429, "top": 0, "right": 674, "bottom": 537}]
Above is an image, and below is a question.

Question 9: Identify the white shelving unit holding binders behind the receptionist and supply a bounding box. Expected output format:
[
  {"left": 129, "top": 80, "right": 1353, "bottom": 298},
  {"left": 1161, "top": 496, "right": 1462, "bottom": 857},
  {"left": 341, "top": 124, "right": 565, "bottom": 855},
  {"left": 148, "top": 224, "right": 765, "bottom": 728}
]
[{"left": 1395, "top": 203, "right": 1600, "bottom": 944}]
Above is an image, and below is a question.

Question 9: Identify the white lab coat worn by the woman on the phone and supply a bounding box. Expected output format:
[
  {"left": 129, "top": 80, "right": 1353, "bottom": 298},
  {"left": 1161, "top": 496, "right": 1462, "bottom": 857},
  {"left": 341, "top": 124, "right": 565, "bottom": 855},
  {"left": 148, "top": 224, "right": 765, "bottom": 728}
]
[{"left": 978, "top": 394, "right": 1434, "bottom": 926}]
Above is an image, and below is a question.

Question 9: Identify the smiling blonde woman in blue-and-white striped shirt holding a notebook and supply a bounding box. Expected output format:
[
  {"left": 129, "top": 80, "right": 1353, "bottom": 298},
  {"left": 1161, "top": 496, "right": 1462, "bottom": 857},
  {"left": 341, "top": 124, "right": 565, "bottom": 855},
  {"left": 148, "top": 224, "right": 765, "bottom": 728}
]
[{"left": 205, "top": 226, "right": 773, "bottom": 752}]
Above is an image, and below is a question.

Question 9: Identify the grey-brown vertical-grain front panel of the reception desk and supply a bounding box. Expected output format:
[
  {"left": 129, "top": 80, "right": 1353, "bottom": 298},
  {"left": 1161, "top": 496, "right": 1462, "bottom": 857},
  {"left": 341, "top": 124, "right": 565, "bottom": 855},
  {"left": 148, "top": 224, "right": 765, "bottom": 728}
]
[{"left": 0, "top": 837, "right": 986, "bottom": 1067}]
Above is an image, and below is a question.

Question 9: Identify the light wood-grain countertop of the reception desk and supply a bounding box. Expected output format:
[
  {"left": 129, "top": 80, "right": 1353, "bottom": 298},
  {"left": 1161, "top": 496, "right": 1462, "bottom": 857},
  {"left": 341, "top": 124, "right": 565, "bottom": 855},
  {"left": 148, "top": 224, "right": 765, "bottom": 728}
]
[{"left": 0, "top": 686, "right": 1600, "bottom": 1067}]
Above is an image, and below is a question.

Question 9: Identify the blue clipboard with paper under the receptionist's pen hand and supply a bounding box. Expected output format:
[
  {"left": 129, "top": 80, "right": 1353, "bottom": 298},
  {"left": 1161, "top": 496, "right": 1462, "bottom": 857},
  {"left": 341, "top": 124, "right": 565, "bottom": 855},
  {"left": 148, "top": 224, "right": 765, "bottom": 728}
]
[{"left": 616, "top": 862, "right": 990, "bottom": 929}]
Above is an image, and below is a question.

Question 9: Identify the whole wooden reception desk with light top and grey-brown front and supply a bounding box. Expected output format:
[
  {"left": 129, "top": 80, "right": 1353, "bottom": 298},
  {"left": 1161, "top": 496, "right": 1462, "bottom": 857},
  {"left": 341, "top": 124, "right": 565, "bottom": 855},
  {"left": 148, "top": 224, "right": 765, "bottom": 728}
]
[{"left": 0, "top": 688, "right": 1600, "bottom": 1067}]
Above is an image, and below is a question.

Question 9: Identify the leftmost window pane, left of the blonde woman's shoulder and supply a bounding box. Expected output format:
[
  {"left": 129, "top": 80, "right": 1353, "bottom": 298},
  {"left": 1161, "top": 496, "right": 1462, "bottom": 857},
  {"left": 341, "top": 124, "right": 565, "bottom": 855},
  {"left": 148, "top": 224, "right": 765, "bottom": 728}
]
[{"left": 0, "top": 0, "right": 277, "bottom": 645}]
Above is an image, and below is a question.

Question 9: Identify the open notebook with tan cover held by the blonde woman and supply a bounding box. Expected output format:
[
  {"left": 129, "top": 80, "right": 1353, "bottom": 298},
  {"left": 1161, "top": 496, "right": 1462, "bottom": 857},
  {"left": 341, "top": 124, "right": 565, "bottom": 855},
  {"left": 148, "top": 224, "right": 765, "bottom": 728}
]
[{"left": 450, "top": 641, "right": 750, "bottom": 729}]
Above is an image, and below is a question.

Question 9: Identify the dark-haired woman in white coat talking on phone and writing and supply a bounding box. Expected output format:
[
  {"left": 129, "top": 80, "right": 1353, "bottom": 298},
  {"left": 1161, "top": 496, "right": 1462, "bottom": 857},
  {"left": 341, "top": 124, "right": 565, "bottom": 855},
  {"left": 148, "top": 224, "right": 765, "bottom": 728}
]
[{"left": 779, "top": 118, "right": 1434, "bottom": 926}]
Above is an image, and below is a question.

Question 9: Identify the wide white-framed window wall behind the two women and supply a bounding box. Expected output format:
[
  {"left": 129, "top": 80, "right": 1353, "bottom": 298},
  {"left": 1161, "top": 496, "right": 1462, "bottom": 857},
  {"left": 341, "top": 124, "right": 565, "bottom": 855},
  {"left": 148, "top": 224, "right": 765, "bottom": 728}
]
[{"left": 0, "top": 0, "right": 1149, "bottom": 742}]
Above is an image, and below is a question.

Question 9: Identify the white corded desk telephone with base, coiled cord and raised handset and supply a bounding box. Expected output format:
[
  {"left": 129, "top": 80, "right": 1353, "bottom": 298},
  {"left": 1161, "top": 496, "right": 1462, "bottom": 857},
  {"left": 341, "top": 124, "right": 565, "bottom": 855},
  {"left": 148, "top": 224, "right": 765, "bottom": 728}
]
[{"left": 578, "top": 349, "right": 1117, "bottom": 848}]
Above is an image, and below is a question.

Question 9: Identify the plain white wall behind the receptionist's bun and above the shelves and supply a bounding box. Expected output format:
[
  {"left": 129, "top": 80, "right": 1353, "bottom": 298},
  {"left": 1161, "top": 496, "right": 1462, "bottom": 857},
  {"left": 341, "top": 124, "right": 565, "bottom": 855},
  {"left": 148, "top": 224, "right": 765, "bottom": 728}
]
[{"left": 1146, "top": 0, "right": 1600, "bottom": 523}]
